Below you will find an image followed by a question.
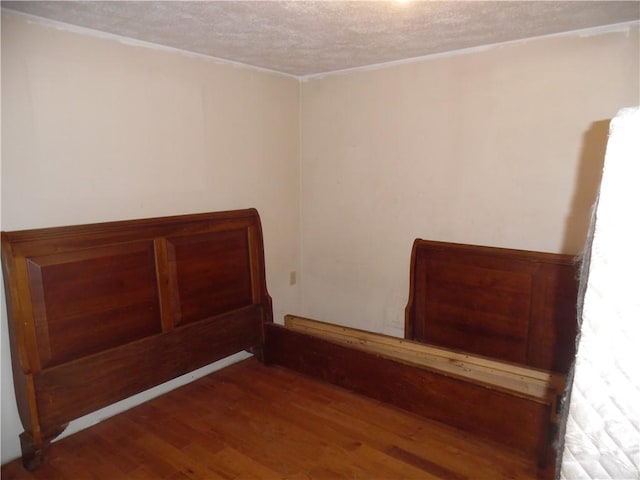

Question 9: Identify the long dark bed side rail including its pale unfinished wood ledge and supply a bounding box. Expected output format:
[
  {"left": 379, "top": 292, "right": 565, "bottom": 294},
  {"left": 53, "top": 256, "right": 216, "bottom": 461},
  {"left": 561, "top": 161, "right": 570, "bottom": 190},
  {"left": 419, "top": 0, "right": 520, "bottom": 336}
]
[{"left": 265, "top": 316, "right": 565, "bottom": 466}]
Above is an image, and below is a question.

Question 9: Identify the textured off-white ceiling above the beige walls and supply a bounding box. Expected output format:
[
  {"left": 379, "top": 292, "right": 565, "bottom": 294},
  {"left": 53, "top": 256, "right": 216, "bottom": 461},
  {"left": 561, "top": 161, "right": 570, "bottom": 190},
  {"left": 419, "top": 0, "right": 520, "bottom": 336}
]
[{"left": 2, "top": 0, "right": 640, "bottom": 76}]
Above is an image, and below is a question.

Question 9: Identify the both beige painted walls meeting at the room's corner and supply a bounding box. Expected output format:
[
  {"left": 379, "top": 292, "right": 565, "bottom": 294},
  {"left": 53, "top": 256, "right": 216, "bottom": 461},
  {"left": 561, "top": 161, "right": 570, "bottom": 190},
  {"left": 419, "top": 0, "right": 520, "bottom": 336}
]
[{"left": 0, "top": 12, "right": 640, "bottom": 462}]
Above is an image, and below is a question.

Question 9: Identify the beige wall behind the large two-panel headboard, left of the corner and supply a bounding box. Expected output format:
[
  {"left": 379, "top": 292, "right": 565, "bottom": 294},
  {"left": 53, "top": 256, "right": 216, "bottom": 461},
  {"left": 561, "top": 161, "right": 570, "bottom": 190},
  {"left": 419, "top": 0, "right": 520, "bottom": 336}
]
[{"left": 1, "top": 12, "right": 299, "bottom": 461}]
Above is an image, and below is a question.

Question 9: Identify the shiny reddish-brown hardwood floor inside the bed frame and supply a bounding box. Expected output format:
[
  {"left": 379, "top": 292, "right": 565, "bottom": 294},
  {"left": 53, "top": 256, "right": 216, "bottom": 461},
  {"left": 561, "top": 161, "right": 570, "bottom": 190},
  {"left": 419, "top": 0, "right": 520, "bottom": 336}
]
[{"left": 1, "top": 359, "right": 550, "bottom": 480}]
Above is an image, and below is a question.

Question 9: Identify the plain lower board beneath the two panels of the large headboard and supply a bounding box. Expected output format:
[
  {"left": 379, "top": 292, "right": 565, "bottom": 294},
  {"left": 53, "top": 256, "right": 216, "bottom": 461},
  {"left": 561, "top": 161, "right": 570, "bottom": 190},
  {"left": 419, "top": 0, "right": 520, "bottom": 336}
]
[{"left": 34, "top": 306, "right": 262, "bottom": 425}]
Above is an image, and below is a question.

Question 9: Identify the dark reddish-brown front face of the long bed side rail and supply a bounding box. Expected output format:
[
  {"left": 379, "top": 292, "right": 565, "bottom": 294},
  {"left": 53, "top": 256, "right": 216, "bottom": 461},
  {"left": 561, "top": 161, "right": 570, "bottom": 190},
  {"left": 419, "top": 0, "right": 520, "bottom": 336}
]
[{"left": 265, "top": 324, "right": 551, "bottom": 464}]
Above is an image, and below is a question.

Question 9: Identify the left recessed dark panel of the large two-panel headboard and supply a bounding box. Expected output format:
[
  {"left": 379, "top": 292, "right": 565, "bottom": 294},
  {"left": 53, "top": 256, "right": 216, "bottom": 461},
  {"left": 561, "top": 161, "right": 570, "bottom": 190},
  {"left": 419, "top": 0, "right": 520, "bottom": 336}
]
[{"left": 27, "top": 242, "right": 161, "bottom": 368}]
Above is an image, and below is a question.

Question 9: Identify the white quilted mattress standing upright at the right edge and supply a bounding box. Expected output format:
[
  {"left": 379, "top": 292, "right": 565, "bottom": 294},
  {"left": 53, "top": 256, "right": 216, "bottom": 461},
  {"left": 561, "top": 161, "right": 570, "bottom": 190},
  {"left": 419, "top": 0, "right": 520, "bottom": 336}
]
[{"left": 561, "top": 108, "right": 640, "bottom": 480}]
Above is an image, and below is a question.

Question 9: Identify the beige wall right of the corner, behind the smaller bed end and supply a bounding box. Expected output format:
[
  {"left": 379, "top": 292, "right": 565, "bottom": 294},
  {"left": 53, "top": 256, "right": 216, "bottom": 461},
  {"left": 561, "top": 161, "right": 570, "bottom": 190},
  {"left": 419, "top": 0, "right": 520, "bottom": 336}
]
[{"left": 301, "top": 26, "right": 640, "bottom": 335}]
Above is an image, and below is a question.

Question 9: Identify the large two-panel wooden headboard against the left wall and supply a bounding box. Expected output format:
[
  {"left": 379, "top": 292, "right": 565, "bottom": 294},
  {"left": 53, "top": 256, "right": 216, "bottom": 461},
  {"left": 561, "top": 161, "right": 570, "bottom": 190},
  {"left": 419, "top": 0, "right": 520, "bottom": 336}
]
[{"left": 2, "top": 209, "right": 273, "bottom": 469}]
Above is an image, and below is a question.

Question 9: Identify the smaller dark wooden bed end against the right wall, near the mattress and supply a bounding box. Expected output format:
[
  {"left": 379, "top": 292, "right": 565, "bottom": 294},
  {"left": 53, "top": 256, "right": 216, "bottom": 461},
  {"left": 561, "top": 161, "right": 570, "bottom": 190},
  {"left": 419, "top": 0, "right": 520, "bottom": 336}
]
[{"left": 405, "top": 239, "right": 578, "bottom": 373}]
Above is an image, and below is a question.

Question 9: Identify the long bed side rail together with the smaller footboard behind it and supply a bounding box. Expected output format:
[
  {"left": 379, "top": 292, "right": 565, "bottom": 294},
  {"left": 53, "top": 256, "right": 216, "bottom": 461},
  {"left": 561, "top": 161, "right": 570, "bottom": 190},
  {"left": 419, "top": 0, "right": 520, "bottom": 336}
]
[{"left": 265, "top": 239, "right": 578, "bottom": 468}]
